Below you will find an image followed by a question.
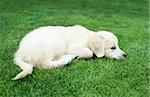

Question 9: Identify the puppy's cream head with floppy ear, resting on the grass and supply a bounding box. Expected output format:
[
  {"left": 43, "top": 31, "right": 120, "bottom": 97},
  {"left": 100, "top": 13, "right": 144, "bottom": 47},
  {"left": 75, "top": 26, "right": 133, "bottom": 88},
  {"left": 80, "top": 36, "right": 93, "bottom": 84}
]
[{"left": 90, "top": 31, "right": 126, "bottom": 59}]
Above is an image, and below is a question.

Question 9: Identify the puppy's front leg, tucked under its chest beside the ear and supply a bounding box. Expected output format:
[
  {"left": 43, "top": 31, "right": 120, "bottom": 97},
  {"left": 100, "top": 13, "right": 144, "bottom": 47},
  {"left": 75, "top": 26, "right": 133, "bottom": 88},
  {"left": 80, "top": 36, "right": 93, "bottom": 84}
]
[{"left": 70, "top": 48, "right": 93, "bottom": 58}]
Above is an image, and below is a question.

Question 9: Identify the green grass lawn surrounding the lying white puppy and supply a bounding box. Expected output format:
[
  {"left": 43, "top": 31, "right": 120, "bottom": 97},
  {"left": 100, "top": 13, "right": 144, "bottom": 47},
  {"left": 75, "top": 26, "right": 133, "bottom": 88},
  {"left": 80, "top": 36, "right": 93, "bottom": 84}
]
[{"left": 0, "top": 0, "right": 150, "bottom": 97}]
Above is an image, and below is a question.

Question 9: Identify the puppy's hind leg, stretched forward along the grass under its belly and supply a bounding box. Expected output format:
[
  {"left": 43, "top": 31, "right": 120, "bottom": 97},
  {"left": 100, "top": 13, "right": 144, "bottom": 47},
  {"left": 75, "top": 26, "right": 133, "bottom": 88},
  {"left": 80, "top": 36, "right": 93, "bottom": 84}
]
[{"left": 45, "top": 55, "right": 76, "bottom": 68}]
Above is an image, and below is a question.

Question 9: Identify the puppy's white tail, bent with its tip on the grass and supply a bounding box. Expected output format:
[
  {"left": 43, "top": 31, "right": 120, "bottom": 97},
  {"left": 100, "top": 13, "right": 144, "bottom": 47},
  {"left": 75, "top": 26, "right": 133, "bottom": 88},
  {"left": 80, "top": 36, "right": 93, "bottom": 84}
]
[{"left": 12, "top": 53, "right": 33, "bottom": 80}]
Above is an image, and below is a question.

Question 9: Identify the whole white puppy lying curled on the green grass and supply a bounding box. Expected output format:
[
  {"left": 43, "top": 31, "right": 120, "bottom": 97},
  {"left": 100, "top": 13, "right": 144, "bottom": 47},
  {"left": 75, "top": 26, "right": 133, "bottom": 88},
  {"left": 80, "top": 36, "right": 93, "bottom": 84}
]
[{"left": 13, "top": 25, "right": 126, "bottom": 80}]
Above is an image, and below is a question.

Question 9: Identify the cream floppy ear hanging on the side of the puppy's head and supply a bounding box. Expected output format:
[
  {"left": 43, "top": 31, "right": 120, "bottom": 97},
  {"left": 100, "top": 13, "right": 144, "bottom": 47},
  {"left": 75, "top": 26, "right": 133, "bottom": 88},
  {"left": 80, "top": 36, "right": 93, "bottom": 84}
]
[{"left": 89, "top": 35, "right": 105, "bottom": 58}]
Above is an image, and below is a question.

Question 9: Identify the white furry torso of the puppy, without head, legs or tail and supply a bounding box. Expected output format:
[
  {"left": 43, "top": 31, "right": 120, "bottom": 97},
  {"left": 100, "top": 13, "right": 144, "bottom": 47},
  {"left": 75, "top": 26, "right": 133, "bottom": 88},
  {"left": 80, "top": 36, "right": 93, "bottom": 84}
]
[{"left": 17, "top": 26, "right": 88, "bottom": 66}]
